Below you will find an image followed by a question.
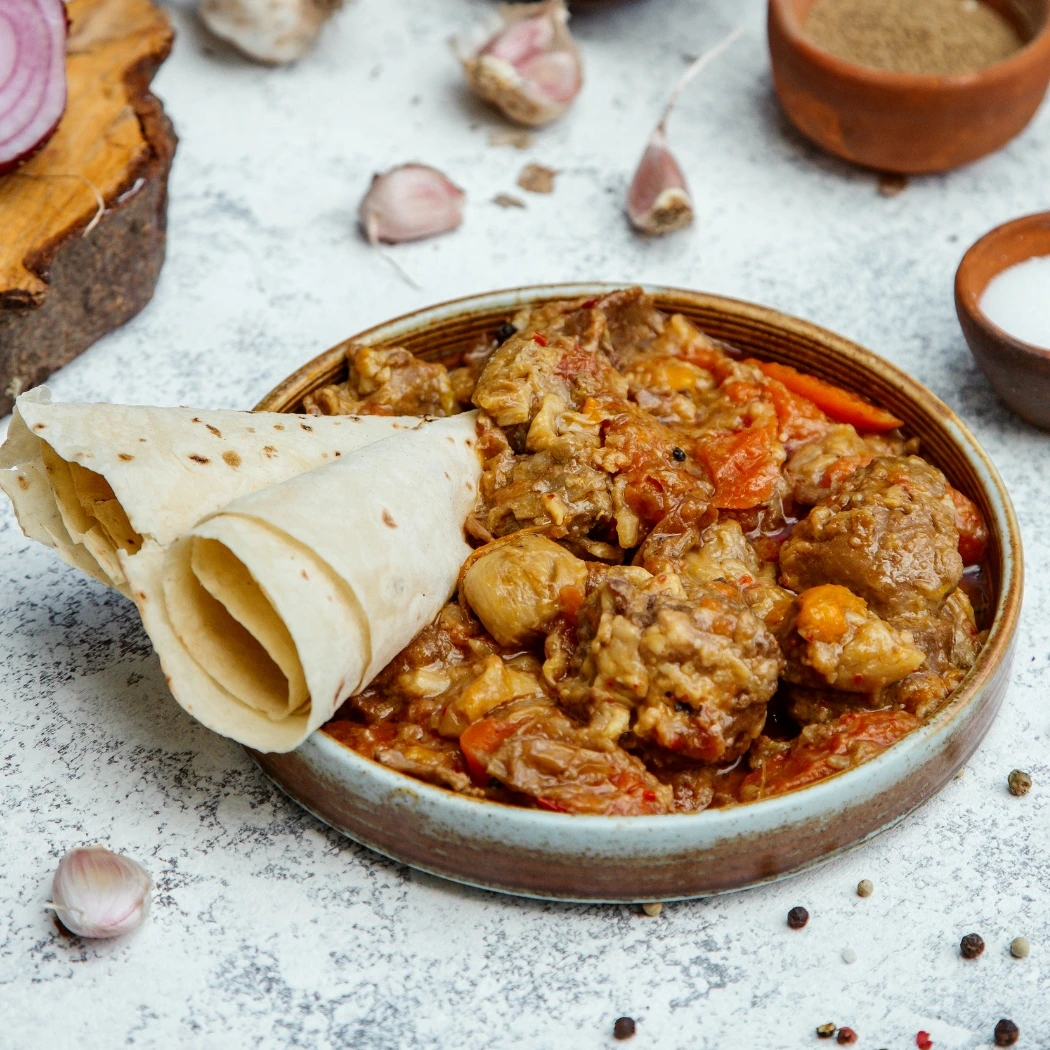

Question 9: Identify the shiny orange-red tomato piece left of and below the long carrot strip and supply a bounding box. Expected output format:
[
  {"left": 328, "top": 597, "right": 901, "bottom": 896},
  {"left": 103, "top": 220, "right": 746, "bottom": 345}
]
[{"left": 696, "top": 423, "right": 784, "bottom": 510}]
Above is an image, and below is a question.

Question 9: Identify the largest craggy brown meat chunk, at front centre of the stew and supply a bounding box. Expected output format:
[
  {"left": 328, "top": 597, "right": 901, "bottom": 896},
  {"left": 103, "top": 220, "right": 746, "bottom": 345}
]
[{"left": 544, "top": 569, "right": 781, "bottom": 762}]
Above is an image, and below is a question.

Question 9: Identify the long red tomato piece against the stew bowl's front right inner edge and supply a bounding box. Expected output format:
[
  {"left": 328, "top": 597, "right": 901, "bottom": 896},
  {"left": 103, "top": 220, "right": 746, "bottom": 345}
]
[{"left": 740, "top": 711, "right": 920, "bottom": 799}]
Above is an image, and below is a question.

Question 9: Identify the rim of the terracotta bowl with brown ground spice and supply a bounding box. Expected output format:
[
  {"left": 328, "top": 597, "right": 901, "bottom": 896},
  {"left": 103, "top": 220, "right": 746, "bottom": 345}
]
[{"left": 770, "top": 0, "right": 1050, "bottom": 95}]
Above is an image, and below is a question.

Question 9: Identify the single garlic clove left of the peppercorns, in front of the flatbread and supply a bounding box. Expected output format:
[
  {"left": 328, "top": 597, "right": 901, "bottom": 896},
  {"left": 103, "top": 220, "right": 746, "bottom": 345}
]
[{"left": 48, "top": 846, "right": 153, "bottom": 938}]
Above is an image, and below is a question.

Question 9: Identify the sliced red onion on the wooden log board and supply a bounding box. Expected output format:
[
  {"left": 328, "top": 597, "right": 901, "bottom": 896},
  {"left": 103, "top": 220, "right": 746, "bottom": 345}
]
[{"left": 0, "top": 0, "right": 68, "bottom": 174}]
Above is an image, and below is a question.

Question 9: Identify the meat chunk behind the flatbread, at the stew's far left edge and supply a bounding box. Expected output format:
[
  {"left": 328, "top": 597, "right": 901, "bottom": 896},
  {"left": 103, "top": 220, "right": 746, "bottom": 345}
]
[{"left": 302, "top": 345, "right": 460, "bottom": 416}]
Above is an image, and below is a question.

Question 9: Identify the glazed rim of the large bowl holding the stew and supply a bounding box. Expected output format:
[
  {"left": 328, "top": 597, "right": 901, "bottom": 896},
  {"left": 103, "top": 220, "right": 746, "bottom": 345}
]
[{"left": 254, "top": 282, "right": 1024, "bottom": 831}]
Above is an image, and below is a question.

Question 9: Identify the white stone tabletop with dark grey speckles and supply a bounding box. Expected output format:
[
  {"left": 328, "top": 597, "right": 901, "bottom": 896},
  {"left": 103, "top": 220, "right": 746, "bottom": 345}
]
[{"left": 0, "top": 0, "right": 1050, "bottom": 1050}]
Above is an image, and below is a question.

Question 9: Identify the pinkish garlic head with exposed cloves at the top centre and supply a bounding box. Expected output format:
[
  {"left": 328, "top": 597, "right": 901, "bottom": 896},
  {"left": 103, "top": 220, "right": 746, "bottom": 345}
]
[{"left": 453, "top": 0, "right": 583, "bottom": 127}]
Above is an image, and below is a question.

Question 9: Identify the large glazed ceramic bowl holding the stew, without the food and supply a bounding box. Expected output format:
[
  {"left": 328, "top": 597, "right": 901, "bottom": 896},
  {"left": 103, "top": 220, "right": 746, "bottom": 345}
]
[{"left": 243, "top": 285, "right": 1023, "bottom": 902}]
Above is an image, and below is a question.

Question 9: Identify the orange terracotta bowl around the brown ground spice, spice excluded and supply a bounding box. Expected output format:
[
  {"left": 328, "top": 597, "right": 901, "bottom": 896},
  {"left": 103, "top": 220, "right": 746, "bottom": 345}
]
[{"left": 769, "top": 0, "right": 1050, "bottom": 174}]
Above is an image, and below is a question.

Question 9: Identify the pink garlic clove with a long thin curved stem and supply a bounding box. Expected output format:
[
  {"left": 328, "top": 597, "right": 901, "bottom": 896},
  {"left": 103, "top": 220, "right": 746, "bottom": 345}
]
[{"left": 627, "top": 29, "right": 743, "bottom": 235}]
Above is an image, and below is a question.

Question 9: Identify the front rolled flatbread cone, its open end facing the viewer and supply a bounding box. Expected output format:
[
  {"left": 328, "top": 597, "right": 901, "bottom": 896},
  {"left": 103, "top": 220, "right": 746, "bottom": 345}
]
[{"left": 120, "top": 412, "right": 481, "bottom": 752}]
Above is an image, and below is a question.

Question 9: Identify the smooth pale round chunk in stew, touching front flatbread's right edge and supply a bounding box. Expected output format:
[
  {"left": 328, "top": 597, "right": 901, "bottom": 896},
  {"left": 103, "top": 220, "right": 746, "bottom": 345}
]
[{"left": 460, "top": 533, "right": 587, "bottom": 648}]
